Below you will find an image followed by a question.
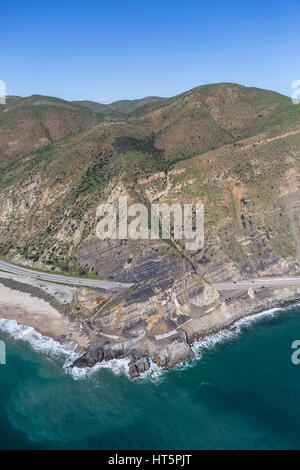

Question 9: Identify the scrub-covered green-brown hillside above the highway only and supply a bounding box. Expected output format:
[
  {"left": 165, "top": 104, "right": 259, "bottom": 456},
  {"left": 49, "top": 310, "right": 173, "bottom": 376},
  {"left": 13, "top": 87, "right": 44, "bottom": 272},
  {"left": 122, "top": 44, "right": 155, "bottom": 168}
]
[{"left": 0, "top": 84, "right": 300, "bottom": 277}]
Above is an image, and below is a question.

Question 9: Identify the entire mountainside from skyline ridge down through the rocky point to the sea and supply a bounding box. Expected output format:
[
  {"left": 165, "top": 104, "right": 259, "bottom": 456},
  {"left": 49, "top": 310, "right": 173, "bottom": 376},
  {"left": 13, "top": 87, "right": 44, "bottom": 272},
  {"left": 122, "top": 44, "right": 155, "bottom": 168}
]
[{"left": 0, "top": 83, "right": 300, "bottom": 376}]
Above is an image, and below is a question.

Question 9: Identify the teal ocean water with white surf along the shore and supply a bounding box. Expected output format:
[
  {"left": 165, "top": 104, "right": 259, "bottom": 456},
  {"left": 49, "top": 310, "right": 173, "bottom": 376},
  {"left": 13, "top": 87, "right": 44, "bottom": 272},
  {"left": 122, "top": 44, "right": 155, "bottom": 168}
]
[{"left": 0, "top": 307, "right": 300, "bottom": 449}]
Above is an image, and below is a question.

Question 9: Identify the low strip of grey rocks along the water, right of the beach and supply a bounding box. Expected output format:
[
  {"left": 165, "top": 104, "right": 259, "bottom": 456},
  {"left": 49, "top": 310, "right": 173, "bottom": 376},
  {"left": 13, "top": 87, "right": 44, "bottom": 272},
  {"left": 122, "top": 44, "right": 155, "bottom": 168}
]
[{"left": 74, "top": 280, "right": 300, "bottom": 378}]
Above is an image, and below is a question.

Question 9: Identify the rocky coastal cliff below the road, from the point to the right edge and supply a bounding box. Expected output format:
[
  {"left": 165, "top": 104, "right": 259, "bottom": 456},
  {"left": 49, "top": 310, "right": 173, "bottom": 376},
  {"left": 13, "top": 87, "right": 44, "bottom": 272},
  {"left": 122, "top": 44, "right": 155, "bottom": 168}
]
[{"left": 69, "top": 276, "right": 300, "bottom": 378}]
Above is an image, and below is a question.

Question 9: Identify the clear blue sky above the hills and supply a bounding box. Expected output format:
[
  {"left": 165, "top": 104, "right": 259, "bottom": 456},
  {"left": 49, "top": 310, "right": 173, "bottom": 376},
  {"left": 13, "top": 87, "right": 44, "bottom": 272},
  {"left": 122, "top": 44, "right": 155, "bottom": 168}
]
[{"left": 0, "top": 0, "right": 300, "bottom": 101}]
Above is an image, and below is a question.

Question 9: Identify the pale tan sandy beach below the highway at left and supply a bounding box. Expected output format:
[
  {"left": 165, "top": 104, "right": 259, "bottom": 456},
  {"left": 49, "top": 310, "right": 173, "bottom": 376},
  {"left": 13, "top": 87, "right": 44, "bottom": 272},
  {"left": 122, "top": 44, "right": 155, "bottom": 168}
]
[{"left": 0, "top": 284, "right": 88, "bottom": 349}]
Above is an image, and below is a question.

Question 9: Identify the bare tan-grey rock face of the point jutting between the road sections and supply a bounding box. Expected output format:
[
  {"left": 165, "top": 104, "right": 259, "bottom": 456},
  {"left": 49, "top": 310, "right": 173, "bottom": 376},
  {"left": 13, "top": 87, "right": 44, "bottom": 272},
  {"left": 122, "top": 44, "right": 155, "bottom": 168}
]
[{"left": 74, "top": 259, "right": 220, "bottom": 378}]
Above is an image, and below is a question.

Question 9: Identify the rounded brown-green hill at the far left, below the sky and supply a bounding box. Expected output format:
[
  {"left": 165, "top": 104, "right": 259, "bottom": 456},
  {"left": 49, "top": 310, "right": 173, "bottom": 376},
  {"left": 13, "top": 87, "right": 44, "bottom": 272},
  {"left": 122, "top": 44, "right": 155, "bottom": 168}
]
[{"left": 0, "top": 95, "right": 102, "bottom": 163}]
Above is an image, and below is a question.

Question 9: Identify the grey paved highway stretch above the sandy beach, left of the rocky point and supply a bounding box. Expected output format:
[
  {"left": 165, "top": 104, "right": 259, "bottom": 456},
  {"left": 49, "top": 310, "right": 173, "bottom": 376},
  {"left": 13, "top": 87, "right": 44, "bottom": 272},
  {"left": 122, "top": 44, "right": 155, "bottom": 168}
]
[{"left": 0, "top": 260, "right": 133, "bottom": 290}]
